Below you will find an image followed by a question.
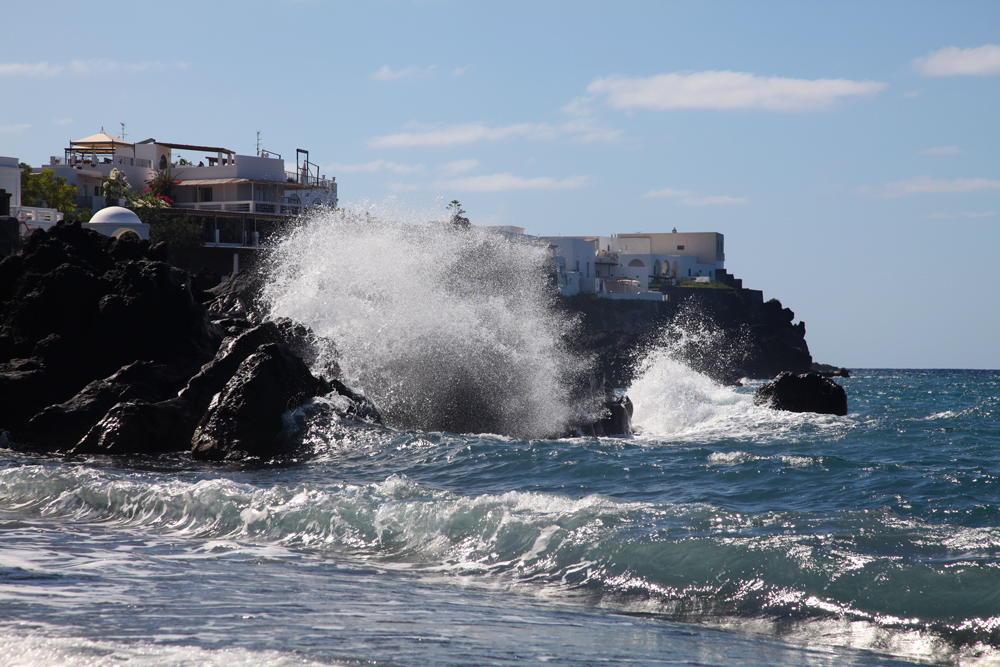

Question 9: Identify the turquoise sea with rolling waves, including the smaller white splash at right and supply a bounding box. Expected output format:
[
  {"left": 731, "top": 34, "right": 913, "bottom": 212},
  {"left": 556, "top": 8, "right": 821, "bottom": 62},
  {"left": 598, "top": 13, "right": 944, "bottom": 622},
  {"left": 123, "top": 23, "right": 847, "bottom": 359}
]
[{"left": 0, "top": 368, "right": 1000, "bottom": 665}]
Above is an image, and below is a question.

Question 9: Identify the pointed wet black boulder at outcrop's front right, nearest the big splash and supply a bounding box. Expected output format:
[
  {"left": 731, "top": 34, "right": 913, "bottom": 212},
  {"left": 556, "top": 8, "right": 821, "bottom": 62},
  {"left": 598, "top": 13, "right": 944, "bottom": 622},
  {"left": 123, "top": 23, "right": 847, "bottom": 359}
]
[{"left": 192, "top": 343, "right": 330, "bottom": 461}]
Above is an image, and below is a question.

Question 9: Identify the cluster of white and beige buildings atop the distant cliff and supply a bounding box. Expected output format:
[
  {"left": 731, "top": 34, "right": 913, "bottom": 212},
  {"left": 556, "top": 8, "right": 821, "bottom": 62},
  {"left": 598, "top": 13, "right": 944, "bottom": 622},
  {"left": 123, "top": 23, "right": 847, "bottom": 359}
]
[{"left": 542, "top": 230, "right": 725, "bottom": 300}]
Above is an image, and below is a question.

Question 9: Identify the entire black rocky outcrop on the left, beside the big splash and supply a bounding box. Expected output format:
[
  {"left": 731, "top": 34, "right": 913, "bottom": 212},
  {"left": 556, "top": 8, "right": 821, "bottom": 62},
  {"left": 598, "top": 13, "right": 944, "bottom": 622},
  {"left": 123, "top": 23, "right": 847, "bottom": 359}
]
[{"left": 0, "top": 224, "right": 379, "bottom": 459}]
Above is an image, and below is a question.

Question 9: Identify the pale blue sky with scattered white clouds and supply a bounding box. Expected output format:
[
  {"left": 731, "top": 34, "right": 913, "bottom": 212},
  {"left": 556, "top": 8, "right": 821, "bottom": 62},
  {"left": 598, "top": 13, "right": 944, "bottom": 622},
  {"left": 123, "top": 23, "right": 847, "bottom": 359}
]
[{"left": 0, "top": 0, "right": 1000, "bottom": 369}]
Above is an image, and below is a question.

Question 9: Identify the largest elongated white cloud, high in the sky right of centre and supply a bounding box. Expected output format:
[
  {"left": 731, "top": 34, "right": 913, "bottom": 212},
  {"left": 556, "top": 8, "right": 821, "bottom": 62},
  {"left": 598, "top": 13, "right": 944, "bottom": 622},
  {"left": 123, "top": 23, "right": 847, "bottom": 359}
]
[{"left": 587, "top": 71, "right": 885, "bottom": 111}]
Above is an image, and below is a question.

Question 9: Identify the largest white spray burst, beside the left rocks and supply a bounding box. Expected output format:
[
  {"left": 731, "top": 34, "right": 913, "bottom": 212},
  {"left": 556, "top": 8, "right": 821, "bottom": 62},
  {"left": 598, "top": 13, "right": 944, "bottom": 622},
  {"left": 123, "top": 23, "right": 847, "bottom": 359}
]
[{"left": 264, "top": 207, "right": 586, "bottom": 438}]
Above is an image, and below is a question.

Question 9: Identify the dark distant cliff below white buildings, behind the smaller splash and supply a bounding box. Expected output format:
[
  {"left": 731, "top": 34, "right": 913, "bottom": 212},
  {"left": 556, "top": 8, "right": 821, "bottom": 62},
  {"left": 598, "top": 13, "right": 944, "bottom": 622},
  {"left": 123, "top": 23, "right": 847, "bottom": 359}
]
[{"left": 560, "top": 287, "right": 812, "bottom": 387}]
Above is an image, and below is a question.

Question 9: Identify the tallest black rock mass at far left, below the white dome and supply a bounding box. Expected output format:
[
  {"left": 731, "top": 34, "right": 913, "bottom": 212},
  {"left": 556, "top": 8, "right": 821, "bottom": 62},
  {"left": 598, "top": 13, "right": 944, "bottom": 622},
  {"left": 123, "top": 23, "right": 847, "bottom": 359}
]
[{"left": 0, "top": 223, "right": 222, "bottom": 436}]
